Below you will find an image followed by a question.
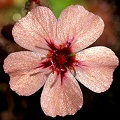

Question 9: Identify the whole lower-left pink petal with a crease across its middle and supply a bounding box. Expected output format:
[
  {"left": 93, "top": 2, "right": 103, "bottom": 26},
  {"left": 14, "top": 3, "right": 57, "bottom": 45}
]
[{"left": 4, "top": 51, "right": 46, "bottom": 96}]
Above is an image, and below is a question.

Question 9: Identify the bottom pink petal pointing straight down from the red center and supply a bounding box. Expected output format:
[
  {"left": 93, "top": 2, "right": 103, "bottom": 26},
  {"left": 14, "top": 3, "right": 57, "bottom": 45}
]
[{"left": 41, "top": 73, "right": 83, "bottom": 117}]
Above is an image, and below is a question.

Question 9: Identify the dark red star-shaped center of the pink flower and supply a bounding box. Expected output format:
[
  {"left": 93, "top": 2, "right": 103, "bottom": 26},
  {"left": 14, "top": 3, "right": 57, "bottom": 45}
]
[{"left": 41, "top": 42, "right": 75, "bottom": 80}]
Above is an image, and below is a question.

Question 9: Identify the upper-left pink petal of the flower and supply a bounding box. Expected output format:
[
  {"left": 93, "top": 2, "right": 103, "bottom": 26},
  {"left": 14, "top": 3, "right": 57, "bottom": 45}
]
[{"left": 12, "top": 6, "right": 57, "bottom": 52}]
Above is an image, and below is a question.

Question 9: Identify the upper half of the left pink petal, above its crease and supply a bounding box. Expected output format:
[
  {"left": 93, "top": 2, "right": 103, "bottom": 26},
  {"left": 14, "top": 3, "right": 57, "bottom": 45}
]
[{"left": 4, "top": 51, "right": 42, "bottom": 73}]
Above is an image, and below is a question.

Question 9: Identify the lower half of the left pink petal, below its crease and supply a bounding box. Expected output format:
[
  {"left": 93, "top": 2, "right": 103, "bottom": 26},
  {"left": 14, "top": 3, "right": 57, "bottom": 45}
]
[{"left": 9, "top": 70, "right": 46, "bottom": 96}]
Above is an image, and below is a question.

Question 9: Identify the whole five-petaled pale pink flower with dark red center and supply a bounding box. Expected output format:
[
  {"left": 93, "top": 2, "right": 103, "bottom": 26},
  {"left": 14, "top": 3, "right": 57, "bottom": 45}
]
[{"left": 4, "top": 5, "right": 119, "bottom": 117}]
